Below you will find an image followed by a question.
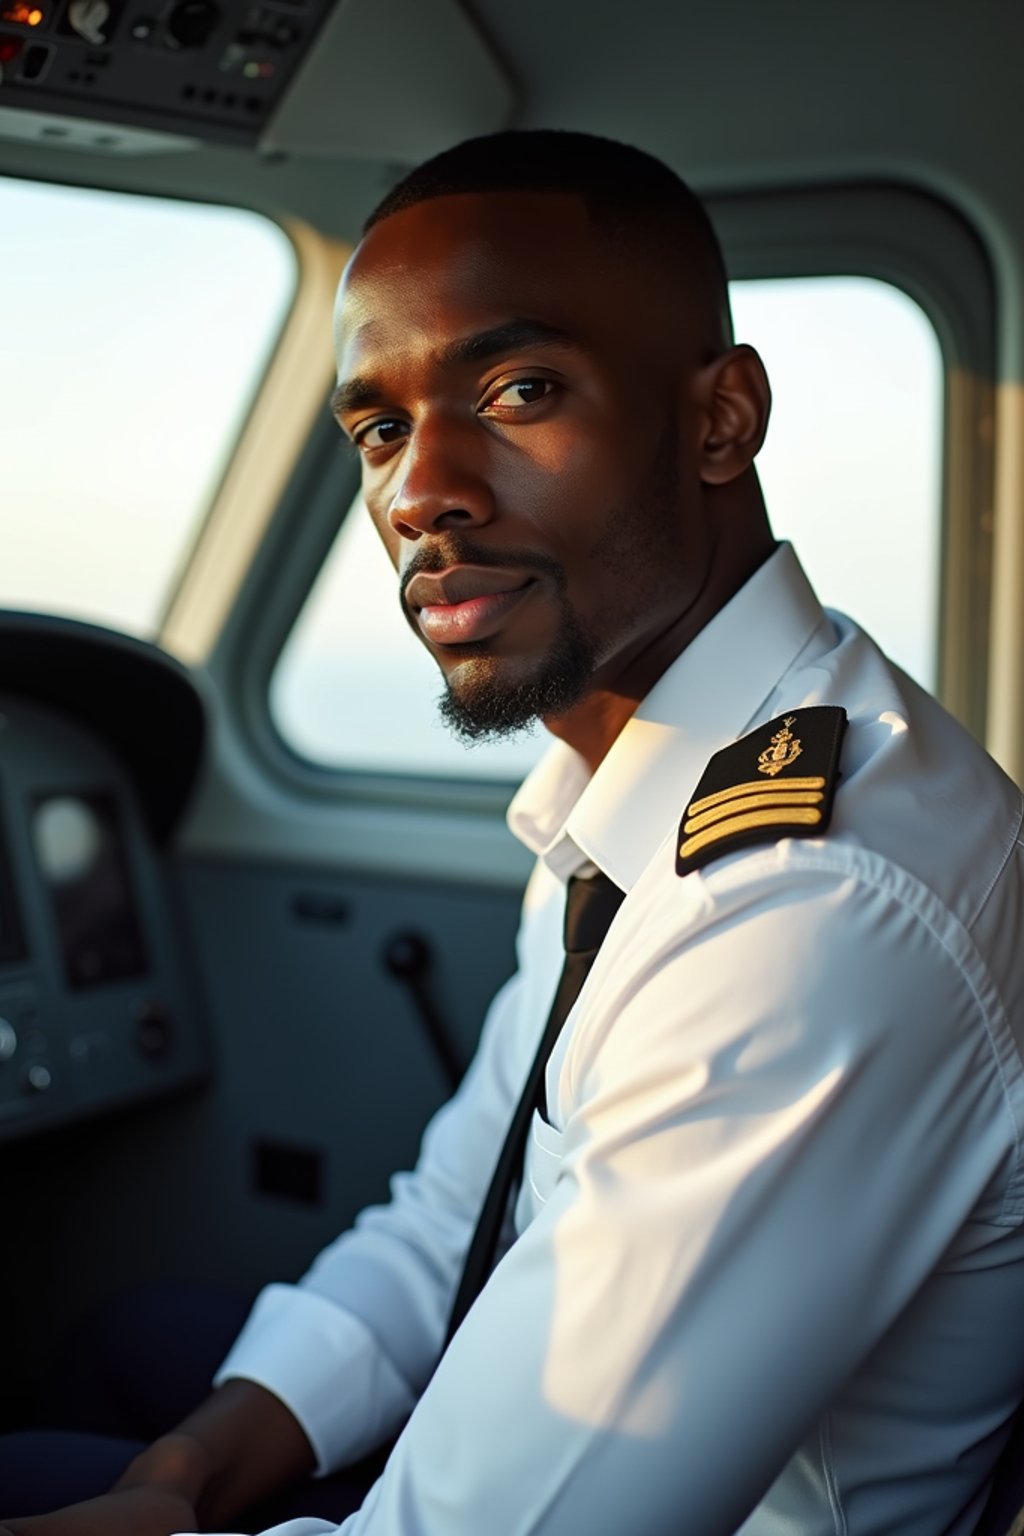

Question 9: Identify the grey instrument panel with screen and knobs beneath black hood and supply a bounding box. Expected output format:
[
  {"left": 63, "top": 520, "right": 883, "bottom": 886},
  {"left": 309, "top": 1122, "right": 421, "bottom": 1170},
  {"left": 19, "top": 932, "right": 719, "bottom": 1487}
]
[{"left": 0, "top": 614, "right": 209, "bottom": 1140}]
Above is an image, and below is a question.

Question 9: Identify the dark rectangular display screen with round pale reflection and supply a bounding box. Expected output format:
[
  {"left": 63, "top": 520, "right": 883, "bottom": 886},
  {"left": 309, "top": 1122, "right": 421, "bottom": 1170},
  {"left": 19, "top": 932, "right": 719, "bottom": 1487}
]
[{"left": 32, "top": 794, "right": 147, "bottom": 989}]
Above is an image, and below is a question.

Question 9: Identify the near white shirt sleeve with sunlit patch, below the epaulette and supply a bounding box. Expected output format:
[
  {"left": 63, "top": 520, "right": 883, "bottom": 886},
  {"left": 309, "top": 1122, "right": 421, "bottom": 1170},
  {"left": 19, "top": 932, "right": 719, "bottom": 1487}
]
[{"left": 322, "top": 854, "right": 1015, "bottom": 1536}]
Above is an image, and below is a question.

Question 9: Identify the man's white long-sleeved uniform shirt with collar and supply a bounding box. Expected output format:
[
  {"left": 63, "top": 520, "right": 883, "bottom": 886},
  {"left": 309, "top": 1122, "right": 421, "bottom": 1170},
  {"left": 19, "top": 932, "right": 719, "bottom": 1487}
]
[{"left": 191, "top": 545, "right": 1024, "bottom": 1536}]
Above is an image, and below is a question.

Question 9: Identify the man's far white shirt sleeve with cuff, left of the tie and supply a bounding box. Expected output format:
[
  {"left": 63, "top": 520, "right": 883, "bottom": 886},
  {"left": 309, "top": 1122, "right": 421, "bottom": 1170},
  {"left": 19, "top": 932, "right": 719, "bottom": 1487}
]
[{"left": 215, "top": 975, "right": 540, "bottom": 1475}]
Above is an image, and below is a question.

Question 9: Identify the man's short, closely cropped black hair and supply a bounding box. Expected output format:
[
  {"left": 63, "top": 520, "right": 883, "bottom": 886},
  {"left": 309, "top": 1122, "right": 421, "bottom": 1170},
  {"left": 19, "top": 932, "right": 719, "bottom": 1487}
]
[{"left": 362, "top": 129, "right": 732, "bottom": 343}]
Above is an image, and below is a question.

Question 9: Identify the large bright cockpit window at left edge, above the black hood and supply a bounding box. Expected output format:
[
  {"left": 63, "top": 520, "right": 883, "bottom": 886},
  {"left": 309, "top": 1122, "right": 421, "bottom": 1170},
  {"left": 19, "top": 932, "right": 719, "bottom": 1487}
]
[{"left": 0, "top": 177, "right": 296, "bottom": 637}]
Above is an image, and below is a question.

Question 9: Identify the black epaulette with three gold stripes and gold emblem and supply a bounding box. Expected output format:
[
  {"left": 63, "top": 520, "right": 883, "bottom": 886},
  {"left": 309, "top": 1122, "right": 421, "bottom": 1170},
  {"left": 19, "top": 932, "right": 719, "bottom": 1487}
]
[{"left": 676, "top": 703, "right": 846, "bottom": 874}]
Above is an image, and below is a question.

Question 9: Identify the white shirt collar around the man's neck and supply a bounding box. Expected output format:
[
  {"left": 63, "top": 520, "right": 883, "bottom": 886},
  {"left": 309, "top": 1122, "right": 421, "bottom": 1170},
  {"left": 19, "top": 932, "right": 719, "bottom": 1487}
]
[{"left": 508, "top": 544, "right": 826, "bottom": 891}]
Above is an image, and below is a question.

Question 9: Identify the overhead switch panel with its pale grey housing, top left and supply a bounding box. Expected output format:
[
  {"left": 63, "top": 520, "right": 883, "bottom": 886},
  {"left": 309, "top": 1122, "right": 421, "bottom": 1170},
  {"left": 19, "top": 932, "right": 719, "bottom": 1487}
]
[{"left": 0, "top": 0, "right": 511, "bottom": 158}]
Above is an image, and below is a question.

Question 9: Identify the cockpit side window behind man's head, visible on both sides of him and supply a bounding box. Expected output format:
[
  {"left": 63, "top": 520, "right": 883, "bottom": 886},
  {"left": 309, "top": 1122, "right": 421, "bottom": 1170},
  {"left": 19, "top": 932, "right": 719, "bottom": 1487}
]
[{"left": 270, "top": 276, "right": 944, "bottom": 780}]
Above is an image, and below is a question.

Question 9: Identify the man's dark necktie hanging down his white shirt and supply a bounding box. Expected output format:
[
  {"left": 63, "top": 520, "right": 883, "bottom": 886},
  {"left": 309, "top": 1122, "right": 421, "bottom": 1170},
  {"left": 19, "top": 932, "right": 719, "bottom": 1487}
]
[{"left": 445, "top": 872, "right": 623, "bottom": 1349}]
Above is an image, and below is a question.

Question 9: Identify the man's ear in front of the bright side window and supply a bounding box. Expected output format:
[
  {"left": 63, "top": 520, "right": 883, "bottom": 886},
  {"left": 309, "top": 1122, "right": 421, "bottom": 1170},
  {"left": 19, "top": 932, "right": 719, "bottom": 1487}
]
[{"left": 695, "top": 346, "right": 772, "bottom": 485}]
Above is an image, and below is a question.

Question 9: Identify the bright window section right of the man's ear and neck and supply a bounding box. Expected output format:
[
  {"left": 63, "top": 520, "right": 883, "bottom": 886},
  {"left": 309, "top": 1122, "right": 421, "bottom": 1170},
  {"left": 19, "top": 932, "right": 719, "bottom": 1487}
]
[{"left": 732, "top": 278, "right": 944, "bottom": 688}]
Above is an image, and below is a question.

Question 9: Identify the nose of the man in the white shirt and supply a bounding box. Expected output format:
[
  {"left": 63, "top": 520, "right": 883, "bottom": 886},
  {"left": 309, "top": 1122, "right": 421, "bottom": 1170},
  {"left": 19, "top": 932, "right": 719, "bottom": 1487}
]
[{"left": 387, "top": 422, "right": 494, "bottom": 539}]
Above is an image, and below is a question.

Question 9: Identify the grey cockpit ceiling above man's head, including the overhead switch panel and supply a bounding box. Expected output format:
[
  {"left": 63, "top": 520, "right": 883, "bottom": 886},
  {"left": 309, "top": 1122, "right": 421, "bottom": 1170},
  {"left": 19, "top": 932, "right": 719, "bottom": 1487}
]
[{"left": 0, "top": 0, "right": 1024, "bottom": 238}]
